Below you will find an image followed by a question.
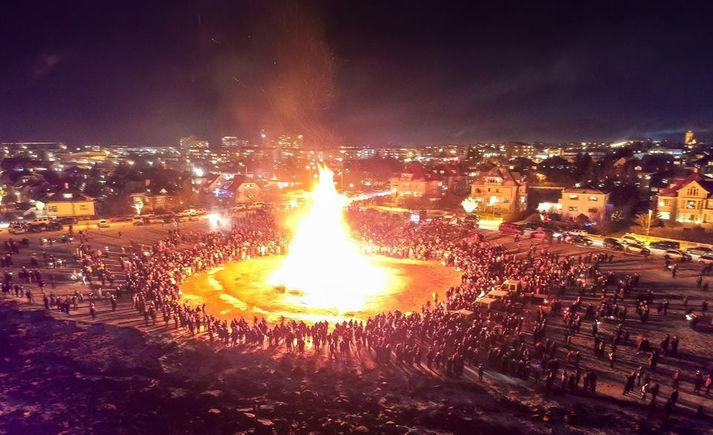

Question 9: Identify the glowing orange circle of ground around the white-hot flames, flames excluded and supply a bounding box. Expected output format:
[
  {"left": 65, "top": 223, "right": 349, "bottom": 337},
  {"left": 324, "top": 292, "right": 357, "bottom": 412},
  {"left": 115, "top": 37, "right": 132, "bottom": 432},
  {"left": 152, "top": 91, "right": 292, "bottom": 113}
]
[{"left": 177, "top": 257, "right": 460, "bottom": 323}]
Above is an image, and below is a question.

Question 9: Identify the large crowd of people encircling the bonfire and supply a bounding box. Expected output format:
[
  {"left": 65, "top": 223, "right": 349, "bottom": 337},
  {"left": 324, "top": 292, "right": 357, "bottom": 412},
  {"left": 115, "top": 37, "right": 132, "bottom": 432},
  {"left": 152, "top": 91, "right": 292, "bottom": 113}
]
[{"left": 3, "top": 209, "right": 713, "bottom": 426}]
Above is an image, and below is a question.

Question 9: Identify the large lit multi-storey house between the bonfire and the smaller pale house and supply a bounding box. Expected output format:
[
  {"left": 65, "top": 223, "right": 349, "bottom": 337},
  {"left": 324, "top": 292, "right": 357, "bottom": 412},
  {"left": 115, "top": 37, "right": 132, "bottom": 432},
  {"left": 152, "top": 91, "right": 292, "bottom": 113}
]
[{"left": 470, "top": 167, "right": 527, "bottom": 215}]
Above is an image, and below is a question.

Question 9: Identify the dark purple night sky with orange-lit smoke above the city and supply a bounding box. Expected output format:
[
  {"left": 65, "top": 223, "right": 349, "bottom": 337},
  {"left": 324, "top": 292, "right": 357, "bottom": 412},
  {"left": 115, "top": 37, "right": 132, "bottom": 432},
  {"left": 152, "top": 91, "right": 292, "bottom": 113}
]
[{"left": 0, "top": 0, "right": 713, "bottom": 145}]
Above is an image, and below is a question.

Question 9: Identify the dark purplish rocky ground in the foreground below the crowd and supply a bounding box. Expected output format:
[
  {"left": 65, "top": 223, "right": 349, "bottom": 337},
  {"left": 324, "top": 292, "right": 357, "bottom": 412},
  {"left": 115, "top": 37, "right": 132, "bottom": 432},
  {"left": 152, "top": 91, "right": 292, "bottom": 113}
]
[{"left": 0, "top": 302, "right": 713, "bottom": 434}]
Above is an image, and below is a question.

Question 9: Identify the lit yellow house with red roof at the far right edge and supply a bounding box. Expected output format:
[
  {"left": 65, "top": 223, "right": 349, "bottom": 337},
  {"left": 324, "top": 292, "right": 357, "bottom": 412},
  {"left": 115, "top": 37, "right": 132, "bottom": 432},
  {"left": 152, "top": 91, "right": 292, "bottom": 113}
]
[{"left": 656, "top": 173, "right": 713, "bottom": 226}]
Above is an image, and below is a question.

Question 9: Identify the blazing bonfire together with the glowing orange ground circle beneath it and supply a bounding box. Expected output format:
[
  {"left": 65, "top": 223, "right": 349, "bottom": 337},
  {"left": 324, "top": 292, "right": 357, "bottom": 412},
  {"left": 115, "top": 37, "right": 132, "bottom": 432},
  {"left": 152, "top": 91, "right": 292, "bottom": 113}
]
[{"left": 181, "top": 168, "right": 460, "bottom": 323}]
